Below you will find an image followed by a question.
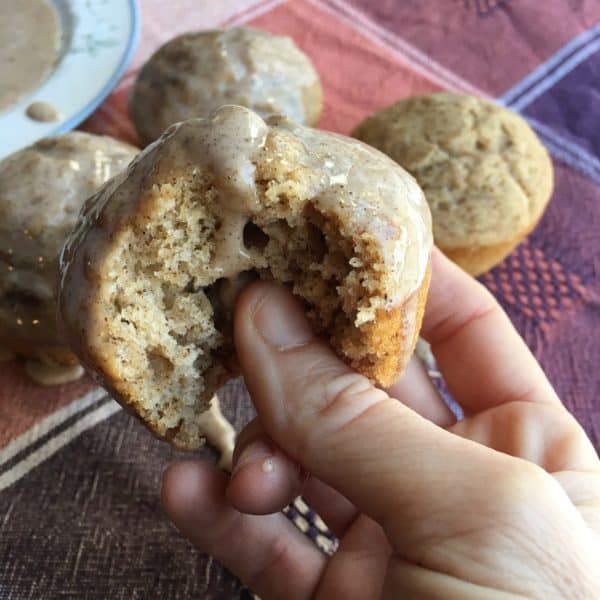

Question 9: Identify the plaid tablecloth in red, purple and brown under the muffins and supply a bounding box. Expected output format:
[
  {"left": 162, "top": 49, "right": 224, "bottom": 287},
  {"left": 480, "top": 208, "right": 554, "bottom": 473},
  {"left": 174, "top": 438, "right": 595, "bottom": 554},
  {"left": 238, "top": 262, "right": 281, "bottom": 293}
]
[{"left": 0, "top": 0, "right": 600, "bottom": 599}]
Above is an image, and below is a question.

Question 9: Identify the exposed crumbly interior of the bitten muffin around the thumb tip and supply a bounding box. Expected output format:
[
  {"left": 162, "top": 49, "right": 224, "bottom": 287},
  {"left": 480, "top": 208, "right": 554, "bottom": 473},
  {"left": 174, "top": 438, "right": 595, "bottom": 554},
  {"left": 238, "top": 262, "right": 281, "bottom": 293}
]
[{"left": 102, "top": 161, "right": 385, "bottom": 448}]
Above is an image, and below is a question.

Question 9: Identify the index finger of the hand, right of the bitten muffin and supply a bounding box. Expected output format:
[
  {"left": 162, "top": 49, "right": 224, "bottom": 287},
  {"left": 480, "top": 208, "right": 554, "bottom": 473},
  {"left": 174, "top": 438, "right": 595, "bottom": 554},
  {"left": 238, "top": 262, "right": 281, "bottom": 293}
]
[{"left": 421, "top": 250, "right": 560, "bottom": 414}]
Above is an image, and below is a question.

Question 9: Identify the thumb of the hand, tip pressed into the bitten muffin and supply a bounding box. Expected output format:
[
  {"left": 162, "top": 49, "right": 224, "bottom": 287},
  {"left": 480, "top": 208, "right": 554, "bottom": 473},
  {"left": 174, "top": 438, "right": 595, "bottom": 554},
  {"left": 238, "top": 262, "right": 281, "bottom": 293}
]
[{"left": 235, "top": 282, "right": 532, "bottom": 550}]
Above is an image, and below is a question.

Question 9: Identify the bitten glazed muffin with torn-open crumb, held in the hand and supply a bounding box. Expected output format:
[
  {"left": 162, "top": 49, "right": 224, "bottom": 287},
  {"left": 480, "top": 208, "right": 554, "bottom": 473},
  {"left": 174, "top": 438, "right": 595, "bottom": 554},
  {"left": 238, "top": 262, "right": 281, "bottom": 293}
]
[{"left": 60, "top": 106, "right": 432, "bottom": 449}]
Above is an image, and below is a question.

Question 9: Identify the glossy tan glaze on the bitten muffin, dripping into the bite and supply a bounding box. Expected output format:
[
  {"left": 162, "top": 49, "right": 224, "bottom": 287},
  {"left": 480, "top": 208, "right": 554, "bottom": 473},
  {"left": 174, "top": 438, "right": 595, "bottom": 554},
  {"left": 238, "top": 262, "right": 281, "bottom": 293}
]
[{"left": 61, "top": 106, "right": 433, "bottom": 326}]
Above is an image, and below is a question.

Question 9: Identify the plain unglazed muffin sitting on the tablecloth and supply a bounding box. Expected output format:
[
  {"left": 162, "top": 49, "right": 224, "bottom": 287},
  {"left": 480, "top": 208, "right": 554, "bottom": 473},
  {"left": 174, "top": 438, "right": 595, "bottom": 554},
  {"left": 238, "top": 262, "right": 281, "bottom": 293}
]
[{"left": 352, "top": 93, "right": 553, "bottom": 275}]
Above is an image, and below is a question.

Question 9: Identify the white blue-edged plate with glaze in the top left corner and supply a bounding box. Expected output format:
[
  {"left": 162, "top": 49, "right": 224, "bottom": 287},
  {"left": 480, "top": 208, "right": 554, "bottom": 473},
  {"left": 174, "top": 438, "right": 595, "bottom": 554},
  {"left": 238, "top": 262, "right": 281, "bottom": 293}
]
[{"left": 0, "top": 0, "right": 140, "bottom": 159}]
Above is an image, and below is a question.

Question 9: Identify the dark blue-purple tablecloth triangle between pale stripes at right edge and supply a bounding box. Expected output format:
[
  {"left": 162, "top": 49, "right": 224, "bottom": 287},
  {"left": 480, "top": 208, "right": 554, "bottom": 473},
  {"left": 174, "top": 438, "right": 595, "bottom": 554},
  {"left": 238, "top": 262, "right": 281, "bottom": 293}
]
[{"left": 523, "top": 51, "right": 600, "bottom": 157}]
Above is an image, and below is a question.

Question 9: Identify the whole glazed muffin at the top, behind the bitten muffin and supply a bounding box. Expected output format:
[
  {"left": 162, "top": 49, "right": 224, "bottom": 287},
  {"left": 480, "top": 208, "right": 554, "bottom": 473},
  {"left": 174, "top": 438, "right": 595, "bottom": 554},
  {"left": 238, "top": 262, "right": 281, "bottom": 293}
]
[{"left": 129, "top": 28, "right": 322, "bottom": 144}]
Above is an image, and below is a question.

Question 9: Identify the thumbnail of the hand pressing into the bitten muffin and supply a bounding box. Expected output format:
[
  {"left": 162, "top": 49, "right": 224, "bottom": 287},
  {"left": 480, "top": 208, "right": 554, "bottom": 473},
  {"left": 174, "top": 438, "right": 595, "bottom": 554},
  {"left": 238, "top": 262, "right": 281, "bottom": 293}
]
[{"left": 253, "top": 288, "right": 313, "bottom": 350}]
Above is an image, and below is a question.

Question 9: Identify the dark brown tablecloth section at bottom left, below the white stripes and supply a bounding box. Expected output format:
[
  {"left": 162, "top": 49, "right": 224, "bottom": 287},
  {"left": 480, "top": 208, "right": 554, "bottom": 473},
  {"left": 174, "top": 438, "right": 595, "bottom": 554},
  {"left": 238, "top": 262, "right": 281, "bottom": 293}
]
[{"left": 0, "top": 381, "right": 254, "bottom": 599}]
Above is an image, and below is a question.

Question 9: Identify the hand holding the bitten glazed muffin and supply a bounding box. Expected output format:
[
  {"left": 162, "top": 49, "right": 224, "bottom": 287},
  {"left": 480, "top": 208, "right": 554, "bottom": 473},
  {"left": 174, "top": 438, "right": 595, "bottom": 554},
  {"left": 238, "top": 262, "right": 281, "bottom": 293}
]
[{"left": 162, "top": 251, "right": 600, "bottom": 600}]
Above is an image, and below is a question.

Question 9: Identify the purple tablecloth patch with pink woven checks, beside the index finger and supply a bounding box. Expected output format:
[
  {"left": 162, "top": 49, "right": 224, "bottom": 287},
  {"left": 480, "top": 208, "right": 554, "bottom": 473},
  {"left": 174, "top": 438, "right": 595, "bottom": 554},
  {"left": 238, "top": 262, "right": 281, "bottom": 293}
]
[{"left": 481, "top": 162, "right": 600, "bottom": 448}]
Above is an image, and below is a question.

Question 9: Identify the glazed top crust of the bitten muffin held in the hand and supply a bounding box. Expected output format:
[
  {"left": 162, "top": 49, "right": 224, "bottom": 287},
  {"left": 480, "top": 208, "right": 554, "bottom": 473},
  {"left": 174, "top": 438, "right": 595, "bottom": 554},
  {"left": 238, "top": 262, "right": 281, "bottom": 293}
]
[{"left": 61, "top": 105, "right": 432, "bottom": 324}]
